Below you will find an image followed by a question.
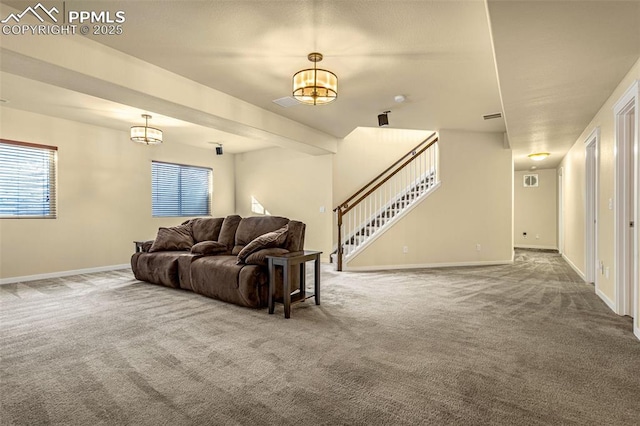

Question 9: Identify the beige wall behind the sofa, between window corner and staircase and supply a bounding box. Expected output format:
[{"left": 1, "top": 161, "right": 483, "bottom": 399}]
[{"left": 235, "top": 148, "right": 333, "bottom": 261}]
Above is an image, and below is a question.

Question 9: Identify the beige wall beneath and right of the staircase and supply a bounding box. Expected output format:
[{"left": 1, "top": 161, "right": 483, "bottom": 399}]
[{"left": 348, "top": 130, "right": 513, "bottom": 269}]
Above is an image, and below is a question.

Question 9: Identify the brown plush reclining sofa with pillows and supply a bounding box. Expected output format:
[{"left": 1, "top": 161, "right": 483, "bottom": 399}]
[{"left": 131, "top": 215, "right": 305, "bottom": 308}]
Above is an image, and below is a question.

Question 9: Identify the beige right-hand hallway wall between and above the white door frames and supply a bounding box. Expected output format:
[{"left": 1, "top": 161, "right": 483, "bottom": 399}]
[{"left": 561, "top": 61, "right": 640, "bottom": 303}]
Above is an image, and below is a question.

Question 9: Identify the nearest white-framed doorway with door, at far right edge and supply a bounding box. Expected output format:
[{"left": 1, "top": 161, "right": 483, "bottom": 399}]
[{"left": 614, "top": 81, "right": 640, "bottom": 338}]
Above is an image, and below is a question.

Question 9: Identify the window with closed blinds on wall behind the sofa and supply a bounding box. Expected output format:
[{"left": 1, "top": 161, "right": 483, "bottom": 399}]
[{"left": 151, "top": 161, "right": 212, "bottom": 216}]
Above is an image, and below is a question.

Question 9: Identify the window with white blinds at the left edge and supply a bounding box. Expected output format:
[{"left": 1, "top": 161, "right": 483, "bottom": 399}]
[{"left": 0, "top": 139, "right": 58, "bottom": 219}]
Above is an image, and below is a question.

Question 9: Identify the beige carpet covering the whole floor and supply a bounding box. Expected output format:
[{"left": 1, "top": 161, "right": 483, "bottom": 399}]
[{"left": 0, "top": 251, "right": 640, "bottom": 425}]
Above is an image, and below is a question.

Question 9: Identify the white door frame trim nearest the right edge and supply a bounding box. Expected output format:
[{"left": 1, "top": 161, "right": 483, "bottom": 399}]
[{"left": 613, "top": 80, "right": 640, "bottom": 338}]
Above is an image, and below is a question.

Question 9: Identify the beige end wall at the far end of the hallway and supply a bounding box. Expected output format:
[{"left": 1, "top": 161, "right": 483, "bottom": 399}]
[{"left": 513, "top": 169, "right": 558, "bottom": 249}]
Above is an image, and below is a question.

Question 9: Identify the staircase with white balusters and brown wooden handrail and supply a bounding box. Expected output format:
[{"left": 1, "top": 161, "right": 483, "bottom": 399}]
[{"left": 331, "top": 133, "right": 439, "bottom": 271}]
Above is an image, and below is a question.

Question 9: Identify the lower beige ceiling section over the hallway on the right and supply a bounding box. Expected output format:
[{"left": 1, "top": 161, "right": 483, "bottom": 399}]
[{"left": 489, "top": 1, "right": 640, "bottom": 169}]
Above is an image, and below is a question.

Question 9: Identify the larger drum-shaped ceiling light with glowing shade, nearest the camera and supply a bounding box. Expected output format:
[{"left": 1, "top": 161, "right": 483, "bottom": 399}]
[{"left": 293, "top": 52, "right": 338, "bottom": 105}]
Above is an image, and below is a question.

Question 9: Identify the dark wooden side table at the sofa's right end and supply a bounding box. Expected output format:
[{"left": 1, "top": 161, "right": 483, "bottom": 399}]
[{"left": 267, "top": 250, "right": 322, "bottom": 318}]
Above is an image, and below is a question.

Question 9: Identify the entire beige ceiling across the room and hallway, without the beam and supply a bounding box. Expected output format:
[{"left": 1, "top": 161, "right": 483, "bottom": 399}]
[{"left": 0, "top": 0, "right": 640, "bottom": 169}]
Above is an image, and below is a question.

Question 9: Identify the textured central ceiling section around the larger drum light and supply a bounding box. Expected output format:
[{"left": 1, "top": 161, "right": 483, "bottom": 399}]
[{"left": 80, "top": 0, "right": 504, "bottom": 137}]
